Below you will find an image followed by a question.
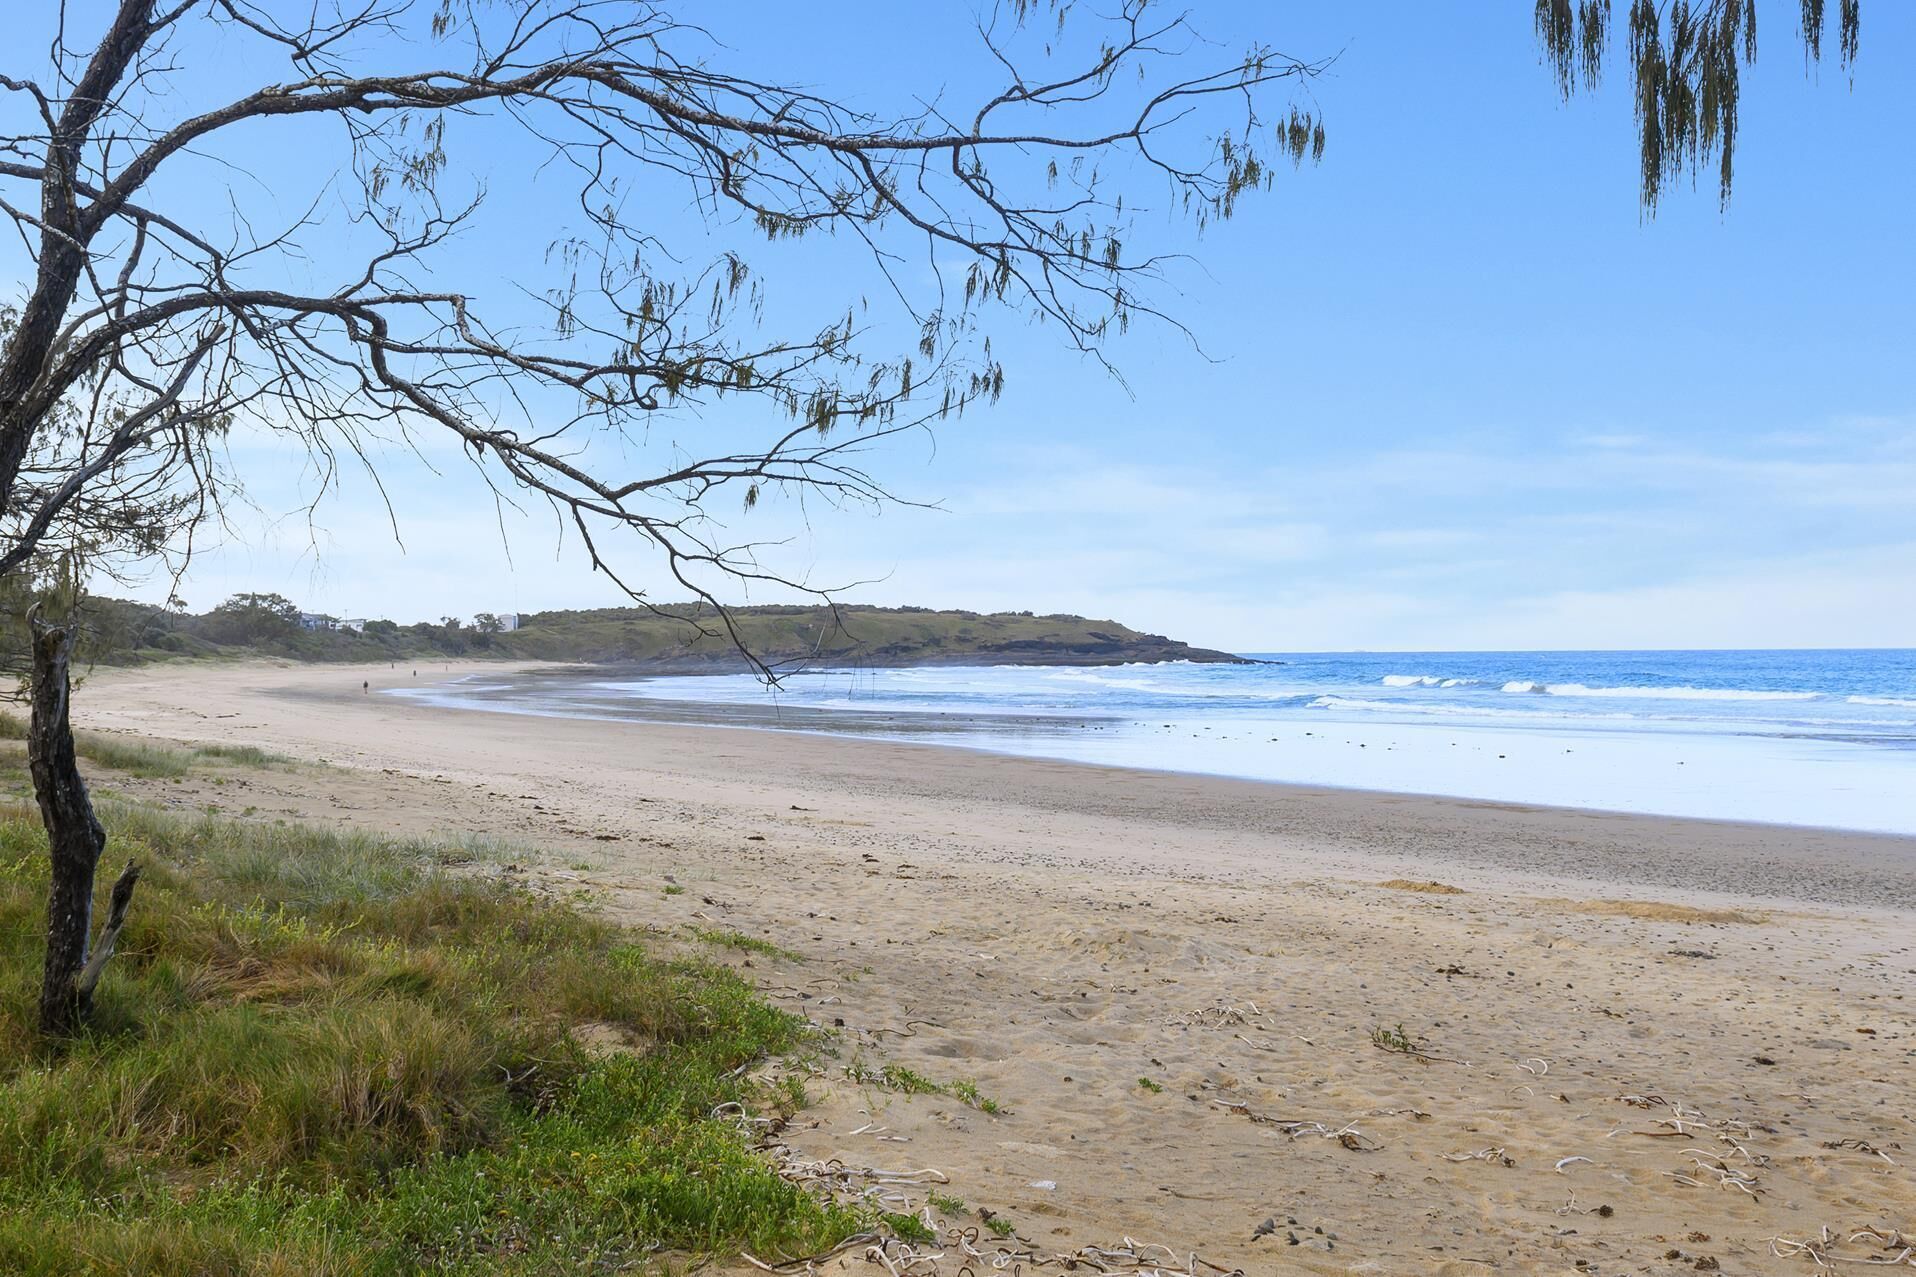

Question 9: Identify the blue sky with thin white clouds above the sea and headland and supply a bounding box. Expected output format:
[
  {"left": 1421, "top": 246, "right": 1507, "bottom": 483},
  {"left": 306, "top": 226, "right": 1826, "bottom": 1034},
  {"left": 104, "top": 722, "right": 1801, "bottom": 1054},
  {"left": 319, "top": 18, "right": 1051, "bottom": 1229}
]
[{"left": 0, "top": 0, "right": 1916, "bottom": 652}]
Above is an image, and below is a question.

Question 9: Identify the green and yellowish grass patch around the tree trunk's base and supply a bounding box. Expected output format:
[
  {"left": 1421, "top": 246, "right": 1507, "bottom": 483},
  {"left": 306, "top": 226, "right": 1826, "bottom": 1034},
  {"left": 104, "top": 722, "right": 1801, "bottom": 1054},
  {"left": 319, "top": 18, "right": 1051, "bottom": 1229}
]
[{"left": 0, "top": 803, "right": 872, "bottom": 1277}]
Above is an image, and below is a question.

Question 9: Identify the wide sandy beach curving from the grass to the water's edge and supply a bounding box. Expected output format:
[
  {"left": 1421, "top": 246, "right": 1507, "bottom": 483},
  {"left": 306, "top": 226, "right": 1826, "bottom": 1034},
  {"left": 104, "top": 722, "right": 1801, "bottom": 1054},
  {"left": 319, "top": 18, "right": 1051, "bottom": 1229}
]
[{"left": 77, "top": 663, "right": 1916, "bottom": 1273}]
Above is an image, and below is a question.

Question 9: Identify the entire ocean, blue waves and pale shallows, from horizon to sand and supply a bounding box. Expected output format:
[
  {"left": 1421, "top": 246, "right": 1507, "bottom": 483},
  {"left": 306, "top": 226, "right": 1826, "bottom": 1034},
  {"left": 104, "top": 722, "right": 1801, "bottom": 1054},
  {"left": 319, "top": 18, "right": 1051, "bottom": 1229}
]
[{"left": 400, "top": 650, "right": 1916, "bottom": 834}]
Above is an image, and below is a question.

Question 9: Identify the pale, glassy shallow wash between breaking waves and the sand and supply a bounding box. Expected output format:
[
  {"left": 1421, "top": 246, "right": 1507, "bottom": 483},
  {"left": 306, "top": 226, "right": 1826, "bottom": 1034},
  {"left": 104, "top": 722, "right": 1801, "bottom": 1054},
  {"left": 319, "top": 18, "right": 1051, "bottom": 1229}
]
[{"left": 400, "top": 655, "right": 1916, "bottom": 836}]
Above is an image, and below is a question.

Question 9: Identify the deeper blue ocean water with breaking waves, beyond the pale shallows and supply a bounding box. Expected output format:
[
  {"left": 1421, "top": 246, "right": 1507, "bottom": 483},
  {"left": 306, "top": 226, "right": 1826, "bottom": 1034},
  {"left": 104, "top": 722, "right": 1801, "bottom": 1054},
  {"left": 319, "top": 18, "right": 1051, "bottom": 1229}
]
[{"left": 634, "top": 648, "right": 1916, "bottom": 748}]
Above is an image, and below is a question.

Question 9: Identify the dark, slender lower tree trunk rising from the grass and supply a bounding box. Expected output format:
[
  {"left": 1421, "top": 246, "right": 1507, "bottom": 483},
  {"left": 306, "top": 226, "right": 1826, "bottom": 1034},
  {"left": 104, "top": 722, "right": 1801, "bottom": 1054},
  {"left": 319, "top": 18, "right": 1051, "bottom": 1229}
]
[{"left": 27, "top": 619, "right": 140, "bottom": 1037}]
